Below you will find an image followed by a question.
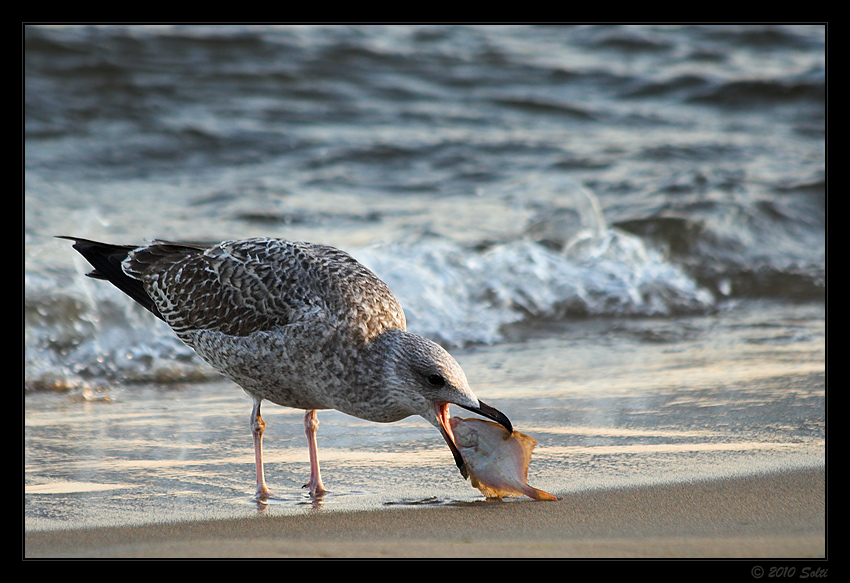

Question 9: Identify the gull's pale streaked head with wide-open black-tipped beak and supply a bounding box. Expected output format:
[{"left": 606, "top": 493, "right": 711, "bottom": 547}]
[{"left": 378, "top": 330, "right": 513, "bottom": 478}]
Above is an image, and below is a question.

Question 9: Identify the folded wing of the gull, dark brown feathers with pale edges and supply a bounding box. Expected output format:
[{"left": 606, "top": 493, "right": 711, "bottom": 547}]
[{"left": 123, "top": 239, "right": 405, "bottom": 339}]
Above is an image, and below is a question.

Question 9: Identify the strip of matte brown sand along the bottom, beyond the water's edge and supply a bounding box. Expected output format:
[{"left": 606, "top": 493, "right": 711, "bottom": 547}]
[{"left": 25, "top": 468, "right": 826, "bottom": 559}]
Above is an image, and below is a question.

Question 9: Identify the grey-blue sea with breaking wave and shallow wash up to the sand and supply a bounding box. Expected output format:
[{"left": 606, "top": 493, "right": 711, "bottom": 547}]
[{"left": 23, "top": 25, "right": 826, "bottom": 528}]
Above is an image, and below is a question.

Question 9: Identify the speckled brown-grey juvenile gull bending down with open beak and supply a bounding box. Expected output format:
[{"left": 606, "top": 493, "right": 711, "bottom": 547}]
[{"left": 61, "top": 237, "right": 512, "bottom": 499}]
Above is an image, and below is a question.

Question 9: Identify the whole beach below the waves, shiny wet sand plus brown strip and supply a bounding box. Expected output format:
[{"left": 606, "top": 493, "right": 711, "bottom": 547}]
[{"left": 23, "top": 302, "right": 827, "bottom": 560}]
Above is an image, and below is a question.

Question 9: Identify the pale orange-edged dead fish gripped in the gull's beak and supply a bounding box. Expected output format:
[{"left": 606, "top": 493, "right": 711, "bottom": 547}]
[{"left": 449, "top": 417, "right": 557, "bottom": 500}]
